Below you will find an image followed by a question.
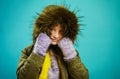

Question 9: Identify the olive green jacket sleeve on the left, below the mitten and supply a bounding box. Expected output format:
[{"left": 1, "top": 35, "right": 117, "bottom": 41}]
[{"left": 16, "top": 47, "right": 44, "bottom": 79}]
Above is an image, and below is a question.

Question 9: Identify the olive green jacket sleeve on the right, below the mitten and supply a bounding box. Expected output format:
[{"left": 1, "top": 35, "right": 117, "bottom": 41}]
[{"left": 67, "top": 56, "right": 89, "bottom": 79}]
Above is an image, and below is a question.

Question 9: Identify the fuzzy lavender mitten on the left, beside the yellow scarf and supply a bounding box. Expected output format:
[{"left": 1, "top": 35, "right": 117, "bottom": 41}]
[{"left": 33, "top": 33, "right": 51, "bottom": 56}]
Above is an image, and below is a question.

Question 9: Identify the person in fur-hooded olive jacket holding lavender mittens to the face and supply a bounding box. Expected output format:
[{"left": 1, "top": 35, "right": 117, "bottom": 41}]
[{"left": 16, "top": 5, "right": 88, "bottom": 79}]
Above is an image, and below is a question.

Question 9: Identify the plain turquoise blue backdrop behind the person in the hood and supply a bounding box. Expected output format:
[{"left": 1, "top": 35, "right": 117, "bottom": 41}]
[{"left": 0, "top": 0, "right": 120, "bottom": 79}]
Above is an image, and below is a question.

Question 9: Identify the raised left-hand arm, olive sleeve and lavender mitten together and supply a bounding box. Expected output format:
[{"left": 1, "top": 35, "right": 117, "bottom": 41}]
[{"left": 17, "top": 33, "right": 51, "bottom": 79}]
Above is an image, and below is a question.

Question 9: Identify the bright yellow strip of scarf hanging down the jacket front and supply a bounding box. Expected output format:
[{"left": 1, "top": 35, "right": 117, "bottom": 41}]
[{"left": 39, "top": 52, "right": 51, "bottom": 79}]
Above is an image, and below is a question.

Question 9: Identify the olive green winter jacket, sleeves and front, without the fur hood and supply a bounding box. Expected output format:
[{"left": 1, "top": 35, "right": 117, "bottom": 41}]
[{"left": 16, "top": 45, "right": 88, "bottom": 79}]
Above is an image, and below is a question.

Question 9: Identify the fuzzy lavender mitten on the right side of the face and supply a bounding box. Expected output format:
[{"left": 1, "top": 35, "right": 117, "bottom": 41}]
[{"left": 58, "top": 37, "right": 77, "bottom": 60}]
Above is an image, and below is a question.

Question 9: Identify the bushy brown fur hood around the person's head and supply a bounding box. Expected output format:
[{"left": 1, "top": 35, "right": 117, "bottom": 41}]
[{"left": 33, "top": 5, "right": 79, "bottom": 42}]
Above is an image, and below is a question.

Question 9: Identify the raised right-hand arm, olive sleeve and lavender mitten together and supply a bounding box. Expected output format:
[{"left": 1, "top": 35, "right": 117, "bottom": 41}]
[{"left": 58, "top": 37, "right": 88, "bottom": 79}]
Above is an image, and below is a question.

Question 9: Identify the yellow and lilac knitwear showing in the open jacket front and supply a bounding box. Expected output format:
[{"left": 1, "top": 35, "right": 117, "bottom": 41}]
[{"left": 39, "top": 51, "right": 59, "bottom": 79}]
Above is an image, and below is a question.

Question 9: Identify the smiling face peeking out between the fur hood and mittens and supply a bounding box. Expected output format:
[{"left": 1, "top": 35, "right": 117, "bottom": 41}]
[{"left": 50, "top": 24, "right": 63, "bottom": 45}]
